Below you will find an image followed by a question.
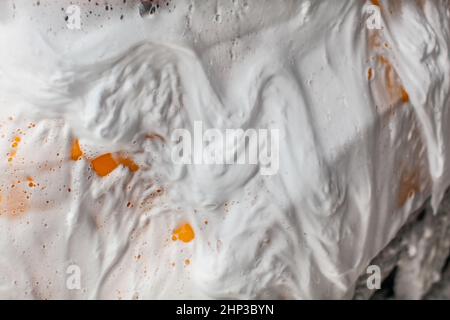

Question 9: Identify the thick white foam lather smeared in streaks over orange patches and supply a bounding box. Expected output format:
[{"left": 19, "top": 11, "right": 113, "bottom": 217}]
[{"left": 0, "top": 0, "right": 450, "bottom": 299}]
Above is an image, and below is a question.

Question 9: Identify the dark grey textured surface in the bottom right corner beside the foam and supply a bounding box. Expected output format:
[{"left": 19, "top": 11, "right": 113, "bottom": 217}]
[{"left": 354, "top": 192, "right": 450, "bottom": 299}]
